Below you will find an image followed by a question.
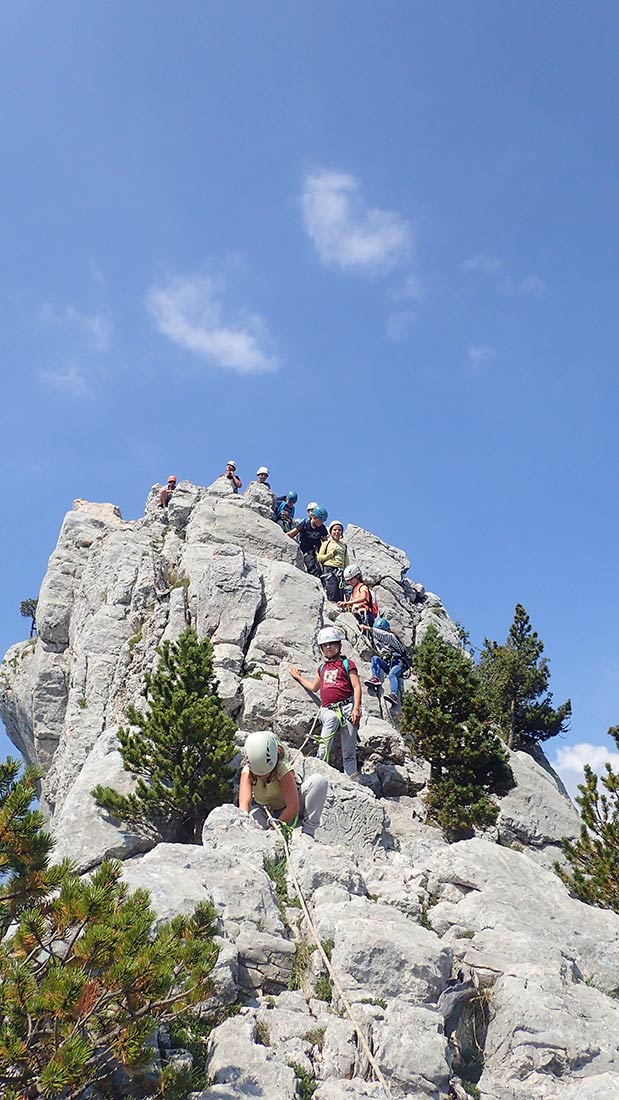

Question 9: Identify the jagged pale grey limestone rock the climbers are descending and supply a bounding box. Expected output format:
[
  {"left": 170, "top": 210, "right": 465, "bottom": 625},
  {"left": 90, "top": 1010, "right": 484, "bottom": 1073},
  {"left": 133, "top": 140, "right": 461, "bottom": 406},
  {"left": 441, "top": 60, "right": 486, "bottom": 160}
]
[{"left": 0, "top": 479, "right": 619, "bottom": 1100}]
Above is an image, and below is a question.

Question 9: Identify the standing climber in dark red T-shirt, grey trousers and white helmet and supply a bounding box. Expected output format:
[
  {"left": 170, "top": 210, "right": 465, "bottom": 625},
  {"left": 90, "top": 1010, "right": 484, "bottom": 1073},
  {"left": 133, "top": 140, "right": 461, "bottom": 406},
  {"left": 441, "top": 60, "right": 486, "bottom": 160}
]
[{"left": 290, "top": 626, "right": 361, "bottom": 782}]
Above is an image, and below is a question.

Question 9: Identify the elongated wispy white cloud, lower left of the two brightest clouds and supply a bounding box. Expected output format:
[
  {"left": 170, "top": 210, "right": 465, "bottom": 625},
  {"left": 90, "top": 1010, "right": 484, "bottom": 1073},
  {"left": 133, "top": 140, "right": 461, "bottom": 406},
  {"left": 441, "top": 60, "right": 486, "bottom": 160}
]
[{"left": 146, "top": 275, "right": 277, "bottom": 374}]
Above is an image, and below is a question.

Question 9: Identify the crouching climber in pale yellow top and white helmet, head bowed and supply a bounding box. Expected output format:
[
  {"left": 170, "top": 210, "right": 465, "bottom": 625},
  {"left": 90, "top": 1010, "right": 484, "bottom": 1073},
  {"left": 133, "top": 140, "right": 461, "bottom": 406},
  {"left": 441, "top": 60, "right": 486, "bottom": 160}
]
[{"left": 239, "top": 730, "right": 329, "bottom": 836}]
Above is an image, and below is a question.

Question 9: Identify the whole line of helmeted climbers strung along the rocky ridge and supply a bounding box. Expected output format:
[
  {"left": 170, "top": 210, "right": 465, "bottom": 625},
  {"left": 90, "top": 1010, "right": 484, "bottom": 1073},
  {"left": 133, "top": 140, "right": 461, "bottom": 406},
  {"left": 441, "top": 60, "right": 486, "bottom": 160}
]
[{"left": 159, "top": 460, "right": 411, "bottom": 836}]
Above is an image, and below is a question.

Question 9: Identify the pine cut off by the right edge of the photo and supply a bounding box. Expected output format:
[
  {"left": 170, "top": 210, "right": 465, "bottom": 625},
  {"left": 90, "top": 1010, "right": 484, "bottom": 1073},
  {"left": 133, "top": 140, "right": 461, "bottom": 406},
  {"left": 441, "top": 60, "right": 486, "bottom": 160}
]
[{"left": 555, "top": 726, "right": 619, "bottom": 913}]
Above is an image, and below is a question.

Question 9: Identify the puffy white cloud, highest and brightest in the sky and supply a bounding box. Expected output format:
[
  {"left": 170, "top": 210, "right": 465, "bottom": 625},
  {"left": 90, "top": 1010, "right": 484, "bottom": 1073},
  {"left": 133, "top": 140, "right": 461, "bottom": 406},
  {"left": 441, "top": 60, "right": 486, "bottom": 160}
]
[{"left": 301, "top": 171, "right": 411, "bottom": 272}]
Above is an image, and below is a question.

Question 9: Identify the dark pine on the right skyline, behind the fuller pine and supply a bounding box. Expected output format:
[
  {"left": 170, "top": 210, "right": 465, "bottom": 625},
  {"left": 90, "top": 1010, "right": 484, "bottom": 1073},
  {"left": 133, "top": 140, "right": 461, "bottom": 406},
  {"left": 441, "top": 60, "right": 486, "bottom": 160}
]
[{"left": 478, "top": 604, "right": 572, "bottom": 749}]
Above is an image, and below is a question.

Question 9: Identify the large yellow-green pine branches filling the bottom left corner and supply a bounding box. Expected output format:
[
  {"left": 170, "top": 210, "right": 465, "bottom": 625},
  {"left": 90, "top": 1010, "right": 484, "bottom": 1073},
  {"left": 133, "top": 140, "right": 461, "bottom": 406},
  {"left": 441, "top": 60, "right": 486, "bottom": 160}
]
[{"left": 0, "top": 760, "right": 218, "bottom": 1100}]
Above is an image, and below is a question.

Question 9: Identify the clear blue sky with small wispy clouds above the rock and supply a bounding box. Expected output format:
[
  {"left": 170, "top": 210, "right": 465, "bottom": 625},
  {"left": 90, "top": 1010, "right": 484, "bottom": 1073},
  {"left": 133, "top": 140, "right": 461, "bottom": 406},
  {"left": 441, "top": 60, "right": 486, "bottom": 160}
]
[{"left": 0, "top": 0, "right": 619, "bottom": 792}]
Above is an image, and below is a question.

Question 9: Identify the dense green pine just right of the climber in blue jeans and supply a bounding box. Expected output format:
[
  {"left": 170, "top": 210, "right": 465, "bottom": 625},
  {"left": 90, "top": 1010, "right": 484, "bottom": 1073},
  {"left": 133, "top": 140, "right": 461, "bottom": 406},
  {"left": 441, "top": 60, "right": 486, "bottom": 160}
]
[{"left": 401, "top": 627, "right": 515, "bottom": 840}]
